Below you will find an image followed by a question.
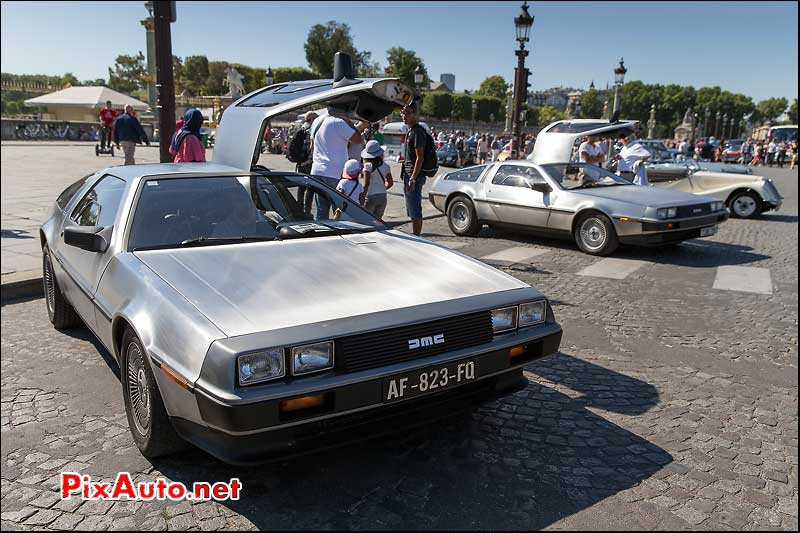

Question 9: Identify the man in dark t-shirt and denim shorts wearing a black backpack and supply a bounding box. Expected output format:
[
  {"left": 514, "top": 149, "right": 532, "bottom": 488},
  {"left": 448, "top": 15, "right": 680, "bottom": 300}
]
[{"left": 400, "top": 102, "right": 439, "bottom": 235}]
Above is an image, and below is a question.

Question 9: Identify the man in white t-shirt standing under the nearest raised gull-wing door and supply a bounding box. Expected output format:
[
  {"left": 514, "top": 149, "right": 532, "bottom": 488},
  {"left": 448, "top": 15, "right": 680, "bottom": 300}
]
[{"left": 311, "top": 109, "right": 369, "bottom": 220}]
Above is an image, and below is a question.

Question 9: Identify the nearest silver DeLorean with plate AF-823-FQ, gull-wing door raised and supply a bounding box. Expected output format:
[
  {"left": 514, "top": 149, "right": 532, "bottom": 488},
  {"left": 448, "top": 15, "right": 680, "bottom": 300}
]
[{"left": 40, "top": 53, "right": 561, "bottom": 463}]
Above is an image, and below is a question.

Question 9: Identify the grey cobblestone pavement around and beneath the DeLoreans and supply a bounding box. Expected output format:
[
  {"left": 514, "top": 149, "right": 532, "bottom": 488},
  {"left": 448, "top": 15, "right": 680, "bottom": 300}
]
[{"left": 0, "top": 165, "right": 798, "bottom": 530}]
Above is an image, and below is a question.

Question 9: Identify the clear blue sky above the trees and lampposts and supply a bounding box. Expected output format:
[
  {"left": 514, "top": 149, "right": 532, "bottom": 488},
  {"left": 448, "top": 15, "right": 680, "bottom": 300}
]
[{"left": 0, "top": 0, "right": 798, "bottom": 102}]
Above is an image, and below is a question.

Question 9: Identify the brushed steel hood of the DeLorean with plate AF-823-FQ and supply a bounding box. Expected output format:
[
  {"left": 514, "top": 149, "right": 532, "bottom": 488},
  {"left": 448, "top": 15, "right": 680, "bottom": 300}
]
[{"left": 135, "top": 231, "right": 528, "bottom": 337}]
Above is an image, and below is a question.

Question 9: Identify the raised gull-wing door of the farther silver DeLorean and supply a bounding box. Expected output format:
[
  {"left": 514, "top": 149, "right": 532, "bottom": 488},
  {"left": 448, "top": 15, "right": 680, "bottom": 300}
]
[{"left": 528, "top": 119, "right": 639, "bottom": 165}]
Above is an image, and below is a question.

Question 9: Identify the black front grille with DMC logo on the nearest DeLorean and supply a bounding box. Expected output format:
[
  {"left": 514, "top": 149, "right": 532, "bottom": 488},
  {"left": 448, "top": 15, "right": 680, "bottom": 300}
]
[{"left": 336, "top": 311, "right": 493, "bottom": 372}]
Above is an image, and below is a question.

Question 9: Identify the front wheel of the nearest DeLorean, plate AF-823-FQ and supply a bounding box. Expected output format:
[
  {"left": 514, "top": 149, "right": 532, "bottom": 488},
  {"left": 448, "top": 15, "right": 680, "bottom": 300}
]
[{"left": 120, "top": 328, "right": 186, "bottom": 458}]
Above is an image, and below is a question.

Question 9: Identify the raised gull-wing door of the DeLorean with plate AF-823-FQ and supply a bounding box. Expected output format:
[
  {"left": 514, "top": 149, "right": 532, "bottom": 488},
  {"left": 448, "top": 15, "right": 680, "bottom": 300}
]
[{"left": 213, "top": 59, "right": 415, "bottom": 172}]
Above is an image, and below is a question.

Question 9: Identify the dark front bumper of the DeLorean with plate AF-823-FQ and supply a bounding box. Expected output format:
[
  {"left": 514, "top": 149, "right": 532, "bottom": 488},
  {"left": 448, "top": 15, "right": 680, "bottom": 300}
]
[{"left": 172, "top": 322, "right": 562, "bottom": 464}]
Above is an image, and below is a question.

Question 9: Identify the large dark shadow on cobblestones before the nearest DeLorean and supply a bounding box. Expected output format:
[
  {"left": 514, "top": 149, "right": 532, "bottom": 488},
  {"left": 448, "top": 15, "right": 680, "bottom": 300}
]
[{"left": 154, "top": 354, "right": 672, "bottom": 530}]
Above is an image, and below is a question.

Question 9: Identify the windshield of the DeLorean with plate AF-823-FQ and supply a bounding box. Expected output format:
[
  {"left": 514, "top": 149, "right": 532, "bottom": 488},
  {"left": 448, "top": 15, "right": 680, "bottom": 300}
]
[{"left": 129, "top": 174, "right": 385, "bottom": 250}]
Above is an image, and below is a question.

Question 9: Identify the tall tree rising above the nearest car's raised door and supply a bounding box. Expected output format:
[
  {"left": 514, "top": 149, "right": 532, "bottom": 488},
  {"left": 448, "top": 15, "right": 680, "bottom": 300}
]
[{"left": 303, "top": 20, "right": 362, "bottom": 78}]
